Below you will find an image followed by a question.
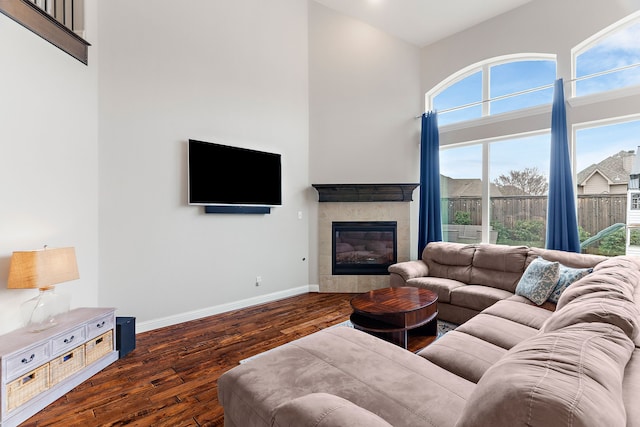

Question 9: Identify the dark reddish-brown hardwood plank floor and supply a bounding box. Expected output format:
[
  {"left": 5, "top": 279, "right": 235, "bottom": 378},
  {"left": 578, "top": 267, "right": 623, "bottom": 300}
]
[{"left": 21, "top": 293, "right": 432, "bottom": 427}]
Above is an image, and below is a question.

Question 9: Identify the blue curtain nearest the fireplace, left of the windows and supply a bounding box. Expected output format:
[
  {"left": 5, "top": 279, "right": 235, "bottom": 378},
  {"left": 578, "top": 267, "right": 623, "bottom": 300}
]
[{"left": 418, "top": 111, "right": 442, "bottom": 258}]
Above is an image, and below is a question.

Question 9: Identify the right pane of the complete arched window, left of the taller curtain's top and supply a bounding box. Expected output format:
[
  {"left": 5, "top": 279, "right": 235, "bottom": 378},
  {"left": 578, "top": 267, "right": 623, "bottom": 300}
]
[{"left": 489, "top": 60, "right": 556, "bottom": 114}]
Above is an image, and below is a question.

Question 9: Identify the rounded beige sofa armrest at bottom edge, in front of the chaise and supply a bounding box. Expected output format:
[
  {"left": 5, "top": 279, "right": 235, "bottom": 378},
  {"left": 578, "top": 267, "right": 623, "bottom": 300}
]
[{"left": 271, "top": 393, "right": 392, "bottom": 427}]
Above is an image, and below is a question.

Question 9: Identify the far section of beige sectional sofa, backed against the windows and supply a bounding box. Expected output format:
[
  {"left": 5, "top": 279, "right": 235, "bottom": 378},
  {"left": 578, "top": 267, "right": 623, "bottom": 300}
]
[{"left": 389, "top": 242, "right": 607, "bottom": 325}]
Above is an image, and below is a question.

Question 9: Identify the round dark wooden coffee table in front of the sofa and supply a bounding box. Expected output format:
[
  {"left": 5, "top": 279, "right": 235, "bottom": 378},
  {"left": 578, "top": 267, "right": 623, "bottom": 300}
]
[{"left": 351, "top": 286, "right": 438, "bottom": 348}]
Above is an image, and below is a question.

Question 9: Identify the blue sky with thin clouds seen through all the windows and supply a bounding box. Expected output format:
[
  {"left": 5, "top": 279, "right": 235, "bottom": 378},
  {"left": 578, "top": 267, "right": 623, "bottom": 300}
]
[{"left": 434, "top": 23, "right": 640, "bottom": 181}]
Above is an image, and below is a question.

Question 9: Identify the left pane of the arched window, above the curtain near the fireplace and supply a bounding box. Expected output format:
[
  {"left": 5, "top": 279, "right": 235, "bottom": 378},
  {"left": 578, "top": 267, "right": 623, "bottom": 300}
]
[{"left": 433, "top": 71, "right": 482, "bottom": 125}]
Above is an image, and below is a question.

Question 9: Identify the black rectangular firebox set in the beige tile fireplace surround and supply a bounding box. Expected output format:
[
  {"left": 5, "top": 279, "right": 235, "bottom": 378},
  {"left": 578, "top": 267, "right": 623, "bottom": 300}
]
[{"left": 331, "top": 221, "right": 398, "bottom": 275}]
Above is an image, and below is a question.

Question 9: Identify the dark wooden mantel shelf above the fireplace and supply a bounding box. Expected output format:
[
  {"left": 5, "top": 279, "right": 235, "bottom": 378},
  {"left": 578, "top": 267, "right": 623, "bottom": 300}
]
[{"left": 311, "top": 184, "right": 420, "bottom": 202}]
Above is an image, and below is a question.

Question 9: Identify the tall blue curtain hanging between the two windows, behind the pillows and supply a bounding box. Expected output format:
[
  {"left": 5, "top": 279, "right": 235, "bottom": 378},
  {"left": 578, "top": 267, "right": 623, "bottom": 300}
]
[{"left": 547, "top": 79, "right": 580, "bottom": 252}]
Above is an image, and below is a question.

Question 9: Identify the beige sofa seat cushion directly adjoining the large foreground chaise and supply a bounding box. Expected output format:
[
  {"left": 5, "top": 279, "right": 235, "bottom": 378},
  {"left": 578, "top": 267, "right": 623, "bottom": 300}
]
[{"left": 418, "top": 330, "right": 507, "bottom": 383}]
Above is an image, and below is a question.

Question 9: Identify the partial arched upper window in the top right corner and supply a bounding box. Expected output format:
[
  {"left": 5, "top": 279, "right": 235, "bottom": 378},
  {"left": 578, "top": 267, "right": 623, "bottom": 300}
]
[{"left": 572, "top": 14, "right": 640, "bottom": 96}]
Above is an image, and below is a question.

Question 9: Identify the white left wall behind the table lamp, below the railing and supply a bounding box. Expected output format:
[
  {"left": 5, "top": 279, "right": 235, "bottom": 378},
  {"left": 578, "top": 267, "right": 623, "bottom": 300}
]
[{"left": 0, "top": 0, "right": 98, "bottom": 334}]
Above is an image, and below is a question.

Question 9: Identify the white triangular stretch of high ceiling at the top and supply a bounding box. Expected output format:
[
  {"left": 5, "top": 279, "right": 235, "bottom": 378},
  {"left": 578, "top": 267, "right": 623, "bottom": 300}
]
[{"left": 315, "top": 0, "right": 532, "bottom": 47}]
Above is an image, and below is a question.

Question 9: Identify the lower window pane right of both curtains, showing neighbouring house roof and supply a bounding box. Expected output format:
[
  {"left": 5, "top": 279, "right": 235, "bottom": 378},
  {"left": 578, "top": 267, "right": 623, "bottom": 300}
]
[{"left": 576, "top": 121, "right": 640, "bottom": 256}]
